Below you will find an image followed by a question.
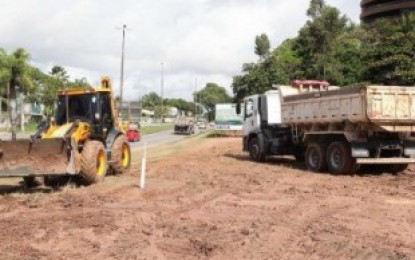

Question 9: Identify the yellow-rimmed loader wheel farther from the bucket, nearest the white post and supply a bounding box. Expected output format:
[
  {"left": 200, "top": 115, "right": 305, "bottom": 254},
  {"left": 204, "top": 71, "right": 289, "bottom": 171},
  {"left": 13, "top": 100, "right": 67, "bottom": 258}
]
[{"left": 110, "top": 135, "right": 131, "bottom": 174}]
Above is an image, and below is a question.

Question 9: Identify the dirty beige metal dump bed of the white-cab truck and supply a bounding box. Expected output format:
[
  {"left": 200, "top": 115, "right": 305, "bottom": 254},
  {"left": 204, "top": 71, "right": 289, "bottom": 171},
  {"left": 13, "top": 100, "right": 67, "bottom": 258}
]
[{"left": 281, "top": 86, "right": 415, "bottom": 132}]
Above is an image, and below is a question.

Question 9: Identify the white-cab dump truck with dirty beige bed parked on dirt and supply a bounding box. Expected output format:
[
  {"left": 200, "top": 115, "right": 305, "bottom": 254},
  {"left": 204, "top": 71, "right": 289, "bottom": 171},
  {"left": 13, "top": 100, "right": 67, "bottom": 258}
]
[{"left": 243, "top": 81, "right": 415, "bottom": 174}]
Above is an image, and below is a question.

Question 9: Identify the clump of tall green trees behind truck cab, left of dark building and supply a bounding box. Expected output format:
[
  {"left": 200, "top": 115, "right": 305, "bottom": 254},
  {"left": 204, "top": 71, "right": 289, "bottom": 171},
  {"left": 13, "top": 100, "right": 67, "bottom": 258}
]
[{"left": 232, "top": 0, "right": 361, "bottom": 101}]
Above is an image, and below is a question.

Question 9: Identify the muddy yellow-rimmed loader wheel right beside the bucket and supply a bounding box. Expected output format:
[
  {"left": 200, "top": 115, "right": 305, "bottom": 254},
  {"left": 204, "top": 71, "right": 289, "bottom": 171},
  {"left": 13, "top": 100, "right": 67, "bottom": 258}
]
[{"left": 80, "top": 141, "right": 108, "bottom": 185}]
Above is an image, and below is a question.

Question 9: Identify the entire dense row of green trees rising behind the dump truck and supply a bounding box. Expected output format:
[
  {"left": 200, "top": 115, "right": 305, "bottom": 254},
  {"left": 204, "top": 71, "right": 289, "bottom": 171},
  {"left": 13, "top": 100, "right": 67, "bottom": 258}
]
[{"left": 231, "top": 0, "right": 415, "bottom": 101}]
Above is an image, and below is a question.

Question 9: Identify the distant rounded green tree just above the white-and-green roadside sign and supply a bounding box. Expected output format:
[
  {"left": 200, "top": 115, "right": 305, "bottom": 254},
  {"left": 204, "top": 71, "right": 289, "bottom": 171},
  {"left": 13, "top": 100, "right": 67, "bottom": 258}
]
[{"left": 194, "top": 83, "right": 231, "bottom": 111}]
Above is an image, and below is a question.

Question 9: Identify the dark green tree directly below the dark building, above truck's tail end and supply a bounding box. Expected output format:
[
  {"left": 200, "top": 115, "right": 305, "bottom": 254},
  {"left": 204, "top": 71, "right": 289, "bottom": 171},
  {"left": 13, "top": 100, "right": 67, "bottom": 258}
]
[{"left": 362, "top": 16, "right": 415, "bottom": 86}]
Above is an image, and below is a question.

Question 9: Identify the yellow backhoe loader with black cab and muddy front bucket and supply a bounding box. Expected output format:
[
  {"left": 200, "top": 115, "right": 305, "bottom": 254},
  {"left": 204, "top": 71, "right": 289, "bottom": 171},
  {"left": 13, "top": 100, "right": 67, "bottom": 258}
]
[{"left": 0, "top": 77, "right": 131, "bottom": 186}]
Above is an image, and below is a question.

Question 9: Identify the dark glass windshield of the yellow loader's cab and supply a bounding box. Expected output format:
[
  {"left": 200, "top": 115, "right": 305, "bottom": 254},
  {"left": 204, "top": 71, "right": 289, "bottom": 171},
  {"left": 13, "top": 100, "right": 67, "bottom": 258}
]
[{"left": 56, "top": 94, "right": 96, "bottom": 125}]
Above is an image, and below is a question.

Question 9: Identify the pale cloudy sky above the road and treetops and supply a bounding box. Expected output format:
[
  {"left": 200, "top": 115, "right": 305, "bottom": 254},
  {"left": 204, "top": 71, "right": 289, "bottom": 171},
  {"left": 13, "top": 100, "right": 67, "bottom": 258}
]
[{"left": 0, "top": 0, "right": 360, "bottom": 100}]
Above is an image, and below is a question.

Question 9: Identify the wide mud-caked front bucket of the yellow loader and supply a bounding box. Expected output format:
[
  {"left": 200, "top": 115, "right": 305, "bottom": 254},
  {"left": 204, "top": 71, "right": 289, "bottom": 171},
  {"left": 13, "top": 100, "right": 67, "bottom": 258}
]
[{"left": 0, "top": 138, "right": 72, "bottom": 177}]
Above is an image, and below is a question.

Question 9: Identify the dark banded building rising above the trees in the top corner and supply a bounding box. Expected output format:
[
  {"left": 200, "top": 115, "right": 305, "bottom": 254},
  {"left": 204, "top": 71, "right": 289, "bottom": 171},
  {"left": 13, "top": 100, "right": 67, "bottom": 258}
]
[{"left": 360, "top": 0, "right": 415, "bottom": 22}]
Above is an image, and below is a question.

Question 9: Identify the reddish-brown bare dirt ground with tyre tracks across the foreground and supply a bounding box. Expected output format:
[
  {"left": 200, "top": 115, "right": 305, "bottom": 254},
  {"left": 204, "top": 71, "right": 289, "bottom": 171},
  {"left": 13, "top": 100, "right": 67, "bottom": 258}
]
[{"left": 0, "top": 138, "right": 415, "bottom": 259}]
